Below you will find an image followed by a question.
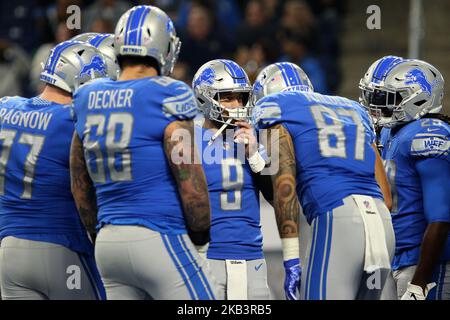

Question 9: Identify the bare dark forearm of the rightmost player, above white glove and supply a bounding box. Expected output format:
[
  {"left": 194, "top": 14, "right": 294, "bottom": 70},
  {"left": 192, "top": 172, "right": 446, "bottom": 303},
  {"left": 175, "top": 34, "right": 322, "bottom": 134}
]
[{"left": 411, "top": 222, "right": 450, "bottom": 288}]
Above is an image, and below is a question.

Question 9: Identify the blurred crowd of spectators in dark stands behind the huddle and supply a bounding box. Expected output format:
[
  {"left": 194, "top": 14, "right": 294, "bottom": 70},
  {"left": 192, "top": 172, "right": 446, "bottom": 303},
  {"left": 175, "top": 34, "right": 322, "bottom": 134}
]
[{"left": 0, "top": 0, "right": 345, "bottom": 96}]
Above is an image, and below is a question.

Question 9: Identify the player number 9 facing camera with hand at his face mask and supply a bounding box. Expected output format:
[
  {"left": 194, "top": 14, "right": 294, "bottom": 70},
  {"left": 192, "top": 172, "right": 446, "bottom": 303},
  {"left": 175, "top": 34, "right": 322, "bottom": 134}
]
[{"left": 192, "top": 59, "right": 272, "bottom": 300}]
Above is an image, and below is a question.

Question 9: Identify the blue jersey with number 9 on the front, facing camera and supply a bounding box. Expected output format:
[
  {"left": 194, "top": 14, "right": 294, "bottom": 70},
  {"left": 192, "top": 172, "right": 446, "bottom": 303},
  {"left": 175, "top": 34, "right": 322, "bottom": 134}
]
[{"left": 195, "top": 120, "right": 263, "bottom": 260}]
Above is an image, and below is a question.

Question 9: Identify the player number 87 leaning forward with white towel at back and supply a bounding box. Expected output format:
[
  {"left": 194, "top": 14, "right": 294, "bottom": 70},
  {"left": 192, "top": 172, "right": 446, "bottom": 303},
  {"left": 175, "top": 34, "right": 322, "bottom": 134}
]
[{"left": 252, "top": 63, "right": 394, "bottom": 300}]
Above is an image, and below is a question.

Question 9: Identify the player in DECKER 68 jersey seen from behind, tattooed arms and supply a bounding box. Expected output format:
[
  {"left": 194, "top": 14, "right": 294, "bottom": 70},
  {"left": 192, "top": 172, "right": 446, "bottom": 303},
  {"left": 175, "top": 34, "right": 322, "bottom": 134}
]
[{"left": 71, "top": 6, "right": 216, "bottom": 299}]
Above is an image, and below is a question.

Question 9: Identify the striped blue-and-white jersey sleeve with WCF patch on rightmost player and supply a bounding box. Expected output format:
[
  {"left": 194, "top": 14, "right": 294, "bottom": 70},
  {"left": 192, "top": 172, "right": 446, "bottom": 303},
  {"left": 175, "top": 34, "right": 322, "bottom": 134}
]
[{"left": 410, "top": 118, "right": 450, "bottom": 159}]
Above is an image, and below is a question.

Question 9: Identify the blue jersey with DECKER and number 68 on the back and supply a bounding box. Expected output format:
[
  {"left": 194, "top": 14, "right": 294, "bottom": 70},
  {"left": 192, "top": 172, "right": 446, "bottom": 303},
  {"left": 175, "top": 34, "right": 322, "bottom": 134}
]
[{"left": 74, "top": 77, "right": 198, "bottom": 234}]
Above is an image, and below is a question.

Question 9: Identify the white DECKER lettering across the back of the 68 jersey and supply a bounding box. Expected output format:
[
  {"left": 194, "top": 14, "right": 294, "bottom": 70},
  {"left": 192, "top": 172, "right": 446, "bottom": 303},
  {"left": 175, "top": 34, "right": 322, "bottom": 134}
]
[{"left": 88, "top": 89, "right": 134, "bottom": 110}]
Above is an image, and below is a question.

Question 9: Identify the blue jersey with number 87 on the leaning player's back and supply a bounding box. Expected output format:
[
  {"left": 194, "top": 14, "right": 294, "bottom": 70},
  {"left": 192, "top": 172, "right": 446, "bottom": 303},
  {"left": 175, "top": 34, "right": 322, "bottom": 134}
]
[{"left": 254, "top": 91, "right": 383, "bottom": 223}]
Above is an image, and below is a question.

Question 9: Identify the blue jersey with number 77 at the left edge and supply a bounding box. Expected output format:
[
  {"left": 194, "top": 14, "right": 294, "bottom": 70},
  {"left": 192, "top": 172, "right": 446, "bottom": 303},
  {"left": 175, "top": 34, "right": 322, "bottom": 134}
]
[{"left": 0, "top": 97, "right": 92, "bottom": 253}]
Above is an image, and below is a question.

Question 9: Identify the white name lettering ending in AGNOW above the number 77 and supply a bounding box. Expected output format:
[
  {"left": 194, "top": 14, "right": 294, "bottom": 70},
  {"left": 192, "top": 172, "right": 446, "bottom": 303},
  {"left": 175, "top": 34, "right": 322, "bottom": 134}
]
[{"left": 0, "top": 108, "right": 53, "bottom": 130}]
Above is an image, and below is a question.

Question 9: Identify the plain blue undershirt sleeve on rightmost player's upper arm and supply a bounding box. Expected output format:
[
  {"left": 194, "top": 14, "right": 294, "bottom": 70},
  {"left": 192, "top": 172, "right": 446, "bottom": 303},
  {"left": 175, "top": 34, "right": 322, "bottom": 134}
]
[{"left": 416, "top": 158, "right": 450, "bottom": 223}]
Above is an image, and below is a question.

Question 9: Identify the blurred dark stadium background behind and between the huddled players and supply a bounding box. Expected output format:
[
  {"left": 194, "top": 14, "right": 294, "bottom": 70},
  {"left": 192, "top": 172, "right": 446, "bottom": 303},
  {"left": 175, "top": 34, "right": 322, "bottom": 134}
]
[{"left": 0, "top": 0, "right": 450, "bottom": 299}]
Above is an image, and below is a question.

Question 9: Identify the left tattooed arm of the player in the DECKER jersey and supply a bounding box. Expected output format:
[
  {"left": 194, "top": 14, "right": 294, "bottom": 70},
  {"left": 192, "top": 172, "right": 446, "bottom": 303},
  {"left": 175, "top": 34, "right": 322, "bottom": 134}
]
[{"left": 70, "top": 132, "right": 97, "bottom": 242}]
